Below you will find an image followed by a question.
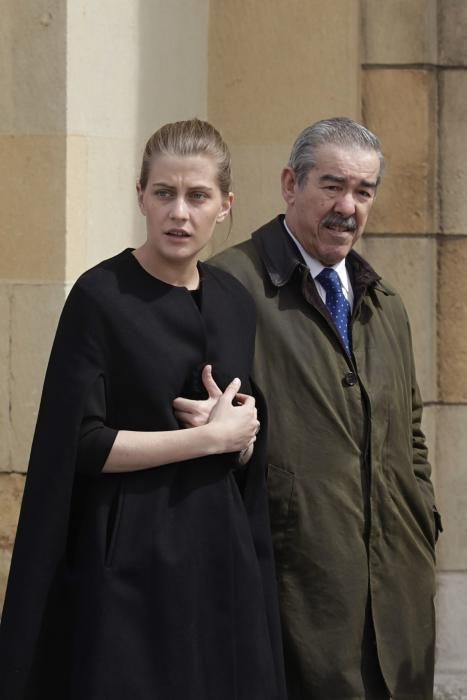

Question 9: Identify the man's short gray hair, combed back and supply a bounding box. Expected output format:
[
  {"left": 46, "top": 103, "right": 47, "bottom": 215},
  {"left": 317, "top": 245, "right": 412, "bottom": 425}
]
[{"left": 288, "top": 117, "right": 384, "bottom": 188}]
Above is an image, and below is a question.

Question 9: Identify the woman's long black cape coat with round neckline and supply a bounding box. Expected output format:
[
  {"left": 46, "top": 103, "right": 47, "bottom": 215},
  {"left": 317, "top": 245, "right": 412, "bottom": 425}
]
[{"left": 0, "top": 249, "right": 285, "bottom": 700}]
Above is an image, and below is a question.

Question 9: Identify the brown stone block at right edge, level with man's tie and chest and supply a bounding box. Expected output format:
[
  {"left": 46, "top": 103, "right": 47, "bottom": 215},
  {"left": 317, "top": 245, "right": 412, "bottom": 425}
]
[{"left": 438, "top": 237, "right": 467, "bottom": 403}]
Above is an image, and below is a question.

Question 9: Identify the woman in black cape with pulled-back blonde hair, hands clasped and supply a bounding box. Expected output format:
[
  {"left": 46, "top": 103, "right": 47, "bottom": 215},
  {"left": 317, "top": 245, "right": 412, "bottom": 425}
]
[{"left": 0, "top": 119, "right": 284, "bottom": 700}]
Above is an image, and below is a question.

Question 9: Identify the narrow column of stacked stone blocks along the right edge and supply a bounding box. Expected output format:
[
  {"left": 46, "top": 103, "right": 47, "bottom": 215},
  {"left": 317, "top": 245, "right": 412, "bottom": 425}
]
[{"left": 437, "top": 0, "right": 467, "bottom": 697}]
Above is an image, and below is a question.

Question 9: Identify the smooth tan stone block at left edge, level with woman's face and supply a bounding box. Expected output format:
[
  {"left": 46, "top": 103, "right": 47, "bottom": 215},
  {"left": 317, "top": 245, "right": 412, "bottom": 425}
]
[{"left": 0, "top": 135, "right": 66, "bottom": 281}]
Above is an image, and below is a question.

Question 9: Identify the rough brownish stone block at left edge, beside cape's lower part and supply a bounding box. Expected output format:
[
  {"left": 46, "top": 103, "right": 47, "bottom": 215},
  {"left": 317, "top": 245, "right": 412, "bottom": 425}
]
[{"left": 0, "top": 474, "right": 24, "bottom": 608}]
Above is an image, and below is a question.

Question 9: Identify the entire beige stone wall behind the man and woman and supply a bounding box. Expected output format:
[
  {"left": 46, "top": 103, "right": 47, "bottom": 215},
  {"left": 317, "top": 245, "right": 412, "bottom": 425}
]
[{"left": 0, "top": 0, "right": 467, "bottom": 697}]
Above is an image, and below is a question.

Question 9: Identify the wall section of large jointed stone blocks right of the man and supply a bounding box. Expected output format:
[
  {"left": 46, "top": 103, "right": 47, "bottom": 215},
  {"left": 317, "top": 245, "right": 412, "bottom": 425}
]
[{"left": 362, "top": 0, "right": 467, "bottom": 697}]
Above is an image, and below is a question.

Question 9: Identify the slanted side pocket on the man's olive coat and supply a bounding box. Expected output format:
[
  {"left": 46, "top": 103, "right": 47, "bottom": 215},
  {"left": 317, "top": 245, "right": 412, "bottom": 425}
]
[{"left": 267, "top": 464, "right": 296, "bottom": 570}]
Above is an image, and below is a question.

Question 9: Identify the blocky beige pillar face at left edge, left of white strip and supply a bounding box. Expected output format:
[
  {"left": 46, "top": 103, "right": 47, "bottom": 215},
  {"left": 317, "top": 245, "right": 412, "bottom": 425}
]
[{"left": 0, "top": 0, "right": 66, "bottom": 598}]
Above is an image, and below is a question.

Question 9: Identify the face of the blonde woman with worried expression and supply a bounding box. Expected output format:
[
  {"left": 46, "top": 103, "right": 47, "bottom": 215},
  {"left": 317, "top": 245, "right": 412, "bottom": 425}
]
[{"left": 137, "top": 155, "right": 233, "bottom": 263}]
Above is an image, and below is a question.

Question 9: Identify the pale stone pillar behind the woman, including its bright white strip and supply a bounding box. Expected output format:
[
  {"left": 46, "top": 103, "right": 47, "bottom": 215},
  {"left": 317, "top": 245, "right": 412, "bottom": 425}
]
[{"left": 0, "top": 0, "right": 208, "bottom": 601}]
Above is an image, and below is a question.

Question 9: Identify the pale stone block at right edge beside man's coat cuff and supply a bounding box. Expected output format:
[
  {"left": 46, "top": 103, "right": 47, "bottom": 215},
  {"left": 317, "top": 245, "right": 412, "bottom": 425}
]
[{"left": 436, "top": 405, "right": 467, "bottom": 568}]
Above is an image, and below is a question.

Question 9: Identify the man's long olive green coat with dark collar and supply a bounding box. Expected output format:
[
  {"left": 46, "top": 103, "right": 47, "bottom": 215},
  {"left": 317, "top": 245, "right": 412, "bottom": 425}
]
[{"left": 214, "top": 218, "right": 440, "bottom": 700}]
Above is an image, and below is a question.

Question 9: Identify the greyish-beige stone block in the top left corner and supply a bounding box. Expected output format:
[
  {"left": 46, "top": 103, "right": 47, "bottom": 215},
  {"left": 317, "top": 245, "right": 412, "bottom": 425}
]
[{"left": 0, "top": 0, "right": 66, "bottom": 134}]
